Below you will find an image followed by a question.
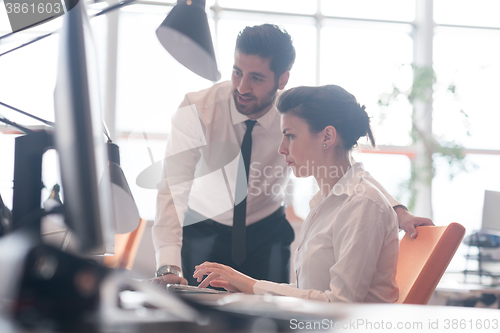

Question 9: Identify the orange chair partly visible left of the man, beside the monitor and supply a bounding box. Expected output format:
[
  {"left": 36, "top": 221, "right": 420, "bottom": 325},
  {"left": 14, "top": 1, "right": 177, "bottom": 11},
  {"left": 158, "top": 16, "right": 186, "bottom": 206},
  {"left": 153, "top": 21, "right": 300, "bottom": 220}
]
[{"left": 104, "top": 219, "right": 147, "bottom": 270}]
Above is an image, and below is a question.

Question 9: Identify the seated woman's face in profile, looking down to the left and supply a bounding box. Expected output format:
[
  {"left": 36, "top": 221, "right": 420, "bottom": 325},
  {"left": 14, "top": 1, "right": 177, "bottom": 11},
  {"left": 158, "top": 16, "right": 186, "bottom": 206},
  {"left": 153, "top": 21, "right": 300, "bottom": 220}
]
[{"left": 278, "top": 113, "right": 322, "bottom": 177}]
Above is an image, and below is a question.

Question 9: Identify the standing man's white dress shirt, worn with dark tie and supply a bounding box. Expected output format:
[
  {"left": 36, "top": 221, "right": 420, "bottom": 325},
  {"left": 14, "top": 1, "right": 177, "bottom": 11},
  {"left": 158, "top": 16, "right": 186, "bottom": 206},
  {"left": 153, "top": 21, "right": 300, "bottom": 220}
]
[{"left": 153, "top": 81, "right": 400, "bottom": 268}]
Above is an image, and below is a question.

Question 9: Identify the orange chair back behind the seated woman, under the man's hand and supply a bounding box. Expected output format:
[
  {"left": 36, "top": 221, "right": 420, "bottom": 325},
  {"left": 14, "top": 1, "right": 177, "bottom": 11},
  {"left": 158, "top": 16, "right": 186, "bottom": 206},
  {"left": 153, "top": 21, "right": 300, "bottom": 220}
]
[{"left": 396, "top": 223, "right": 465, "bottom": 304}]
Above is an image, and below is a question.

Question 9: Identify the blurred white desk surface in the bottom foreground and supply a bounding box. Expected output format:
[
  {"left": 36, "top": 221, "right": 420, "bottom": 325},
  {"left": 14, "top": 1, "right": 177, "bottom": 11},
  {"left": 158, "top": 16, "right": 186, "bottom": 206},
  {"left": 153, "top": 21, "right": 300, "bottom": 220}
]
[{"left": 0, "top": 294, "right": 500, "bottom": 333}]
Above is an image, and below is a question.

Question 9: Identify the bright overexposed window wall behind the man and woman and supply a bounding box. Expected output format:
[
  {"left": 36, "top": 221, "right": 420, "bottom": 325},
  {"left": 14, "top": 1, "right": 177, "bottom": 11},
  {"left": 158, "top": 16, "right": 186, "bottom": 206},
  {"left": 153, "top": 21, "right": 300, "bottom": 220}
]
[{"left": 0, "top": 0, "right": 500, "bottom": 244}]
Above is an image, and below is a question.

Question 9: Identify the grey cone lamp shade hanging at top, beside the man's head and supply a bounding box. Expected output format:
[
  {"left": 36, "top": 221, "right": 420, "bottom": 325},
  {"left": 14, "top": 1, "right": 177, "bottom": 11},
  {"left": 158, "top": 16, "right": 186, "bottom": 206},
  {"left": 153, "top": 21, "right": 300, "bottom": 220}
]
[{"left": 156, "top": 0, "right": 221, "bottom": 81}]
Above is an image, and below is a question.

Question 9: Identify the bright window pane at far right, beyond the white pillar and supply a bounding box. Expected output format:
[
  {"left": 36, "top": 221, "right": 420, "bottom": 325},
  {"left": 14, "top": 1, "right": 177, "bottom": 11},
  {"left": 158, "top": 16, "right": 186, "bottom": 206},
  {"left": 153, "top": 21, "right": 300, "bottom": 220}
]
[{"left": 433, "top": 27, "right": 500, "bottom": 149}]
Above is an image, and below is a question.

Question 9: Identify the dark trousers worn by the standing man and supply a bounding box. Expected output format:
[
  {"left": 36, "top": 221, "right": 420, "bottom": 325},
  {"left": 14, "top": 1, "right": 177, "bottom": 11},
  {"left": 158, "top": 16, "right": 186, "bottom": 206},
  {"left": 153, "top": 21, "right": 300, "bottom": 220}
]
[{"left": 181, "top": 207, "right": 295, "bottom": 285}]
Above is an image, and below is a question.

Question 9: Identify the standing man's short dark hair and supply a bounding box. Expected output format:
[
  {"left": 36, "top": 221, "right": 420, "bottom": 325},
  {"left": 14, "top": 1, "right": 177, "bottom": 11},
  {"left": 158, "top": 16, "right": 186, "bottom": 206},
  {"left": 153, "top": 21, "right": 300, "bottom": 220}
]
[{"left": 236, "top": 24, "right": 295, "bottom": 82}]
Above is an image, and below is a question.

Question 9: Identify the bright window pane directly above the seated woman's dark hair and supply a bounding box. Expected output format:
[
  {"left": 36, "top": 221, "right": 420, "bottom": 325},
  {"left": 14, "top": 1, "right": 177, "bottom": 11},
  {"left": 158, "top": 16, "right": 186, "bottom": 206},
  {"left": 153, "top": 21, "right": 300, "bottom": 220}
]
[{"left": 319, "top": 21, "right": 413, "bottom": 146}]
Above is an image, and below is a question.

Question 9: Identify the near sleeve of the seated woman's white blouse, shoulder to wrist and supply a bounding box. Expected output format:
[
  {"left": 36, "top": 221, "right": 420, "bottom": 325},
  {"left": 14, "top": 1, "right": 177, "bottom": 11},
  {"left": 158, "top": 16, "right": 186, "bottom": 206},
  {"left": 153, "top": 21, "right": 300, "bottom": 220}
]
[{"left": 254, "top": 196, "right": 399, "bottom": 303}]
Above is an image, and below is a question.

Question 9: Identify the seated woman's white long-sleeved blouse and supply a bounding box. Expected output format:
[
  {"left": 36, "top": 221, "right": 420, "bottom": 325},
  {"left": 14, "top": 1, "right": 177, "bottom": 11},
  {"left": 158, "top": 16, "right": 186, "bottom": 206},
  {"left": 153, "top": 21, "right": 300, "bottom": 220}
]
[{"left": 253, "top": 163, "right": 399, "bottom": 303}]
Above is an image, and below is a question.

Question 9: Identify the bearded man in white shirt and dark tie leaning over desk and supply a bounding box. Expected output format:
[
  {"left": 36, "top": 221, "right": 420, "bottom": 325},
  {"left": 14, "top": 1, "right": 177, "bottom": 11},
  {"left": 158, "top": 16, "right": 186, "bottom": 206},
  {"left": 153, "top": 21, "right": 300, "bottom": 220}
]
[{"left": 153, "top": 24, "right": 432, "bottom": 285}]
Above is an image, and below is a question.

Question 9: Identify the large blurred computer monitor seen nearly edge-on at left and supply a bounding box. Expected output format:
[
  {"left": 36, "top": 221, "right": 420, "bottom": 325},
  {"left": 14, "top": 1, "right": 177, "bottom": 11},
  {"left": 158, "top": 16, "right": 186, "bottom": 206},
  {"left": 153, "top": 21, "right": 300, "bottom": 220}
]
[{"left": 54, "top": 1, "right": 114, "bottom": 254}]
